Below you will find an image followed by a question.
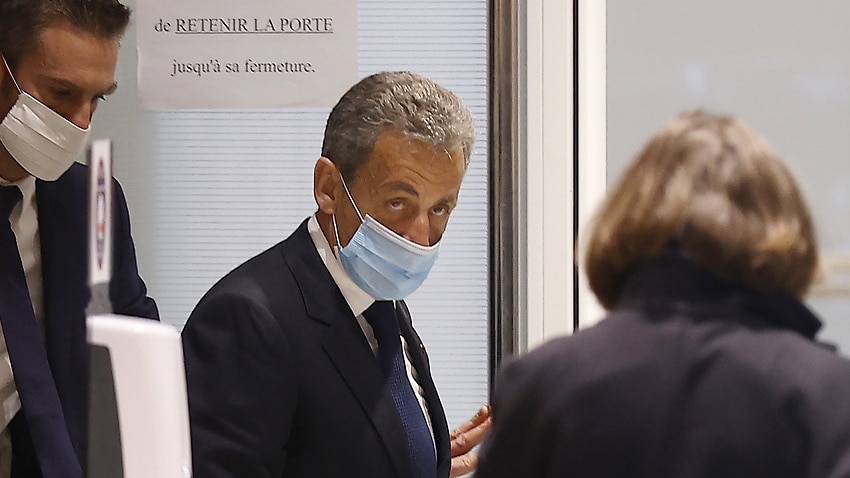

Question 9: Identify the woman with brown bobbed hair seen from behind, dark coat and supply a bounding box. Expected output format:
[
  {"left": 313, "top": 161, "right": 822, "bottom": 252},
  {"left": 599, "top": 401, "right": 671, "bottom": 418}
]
[{"left": 476, "top": 111, "right": 850, "bottom": 478}]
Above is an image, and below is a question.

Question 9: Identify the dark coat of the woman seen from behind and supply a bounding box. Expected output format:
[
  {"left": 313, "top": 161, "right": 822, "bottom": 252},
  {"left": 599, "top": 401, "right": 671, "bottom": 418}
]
[{"left": 475, "top": 254, "right": 850, "bottom": 478}]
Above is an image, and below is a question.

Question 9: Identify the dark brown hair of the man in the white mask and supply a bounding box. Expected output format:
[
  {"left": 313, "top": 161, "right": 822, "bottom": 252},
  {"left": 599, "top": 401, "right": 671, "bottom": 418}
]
[{"left": 0, "top": 0, "right": 130, "bottom": 70}]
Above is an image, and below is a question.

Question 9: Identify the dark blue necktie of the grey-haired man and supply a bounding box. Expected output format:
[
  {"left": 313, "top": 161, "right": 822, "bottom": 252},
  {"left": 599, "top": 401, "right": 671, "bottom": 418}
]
[{"left": 363, "top": 301, "right": 437, "bottom": 478}]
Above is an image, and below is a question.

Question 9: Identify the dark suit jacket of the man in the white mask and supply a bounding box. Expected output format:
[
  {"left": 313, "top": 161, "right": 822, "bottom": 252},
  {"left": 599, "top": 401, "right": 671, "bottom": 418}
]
[{"left": 11, "top": 163, "right": 158, "bottom": 477}]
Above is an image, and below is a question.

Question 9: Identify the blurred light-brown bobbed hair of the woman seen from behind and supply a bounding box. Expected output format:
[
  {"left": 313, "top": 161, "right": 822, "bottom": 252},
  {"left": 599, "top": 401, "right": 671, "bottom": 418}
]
[{"left": 585, "top": 111, "right": 818, "bottom": 308}]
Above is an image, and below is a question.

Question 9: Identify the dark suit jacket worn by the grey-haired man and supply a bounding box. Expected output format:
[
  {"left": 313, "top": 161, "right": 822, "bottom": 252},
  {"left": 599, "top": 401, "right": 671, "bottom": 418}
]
[{"left": 183, "top": 221, "right": 451, "bottom": 478}]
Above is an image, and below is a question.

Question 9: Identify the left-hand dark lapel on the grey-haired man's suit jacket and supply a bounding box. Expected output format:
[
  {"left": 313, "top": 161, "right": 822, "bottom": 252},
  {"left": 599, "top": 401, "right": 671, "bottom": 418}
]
[{"left": 282, "top": 221, "right": 414, "bottom": 477}]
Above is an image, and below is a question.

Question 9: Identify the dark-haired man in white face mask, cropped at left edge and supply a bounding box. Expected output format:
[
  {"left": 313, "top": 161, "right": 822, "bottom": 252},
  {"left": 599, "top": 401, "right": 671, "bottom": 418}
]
[{"left": 0, "top": 0, "right": 158, "bottom": 478}]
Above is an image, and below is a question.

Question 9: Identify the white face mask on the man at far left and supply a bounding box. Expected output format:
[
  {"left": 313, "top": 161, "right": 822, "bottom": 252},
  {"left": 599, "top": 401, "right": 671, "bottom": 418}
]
[{"left": 0, "top": 58, "right": 91, "bottom": 181}]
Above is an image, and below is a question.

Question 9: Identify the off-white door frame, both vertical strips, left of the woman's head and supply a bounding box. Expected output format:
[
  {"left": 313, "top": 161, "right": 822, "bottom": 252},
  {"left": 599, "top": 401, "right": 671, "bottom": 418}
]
[{"left": 520, "top": 0, "right": 606, "bottom": 350}]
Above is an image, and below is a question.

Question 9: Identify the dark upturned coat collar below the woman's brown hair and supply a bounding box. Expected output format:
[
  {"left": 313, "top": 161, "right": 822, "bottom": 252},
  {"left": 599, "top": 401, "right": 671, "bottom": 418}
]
[{"left": 618, "top": 250, "right": 821, "bottom": 340}]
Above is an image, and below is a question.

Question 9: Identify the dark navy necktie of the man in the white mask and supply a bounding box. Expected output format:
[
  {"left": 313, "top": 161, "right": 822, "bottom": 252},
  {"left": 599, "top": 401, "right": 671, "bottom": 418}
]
[{"left": 0, "top": 186, "right": 82, "bottom": 478}]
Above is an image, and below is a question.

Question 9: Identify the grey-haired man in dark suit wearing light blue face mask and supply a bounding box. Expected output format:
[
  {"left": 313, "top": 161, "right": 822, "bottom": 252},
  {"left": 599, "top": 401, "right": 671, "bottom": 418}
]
[{"left": 183, "top": 72, "right": 490, "bottom": 478}]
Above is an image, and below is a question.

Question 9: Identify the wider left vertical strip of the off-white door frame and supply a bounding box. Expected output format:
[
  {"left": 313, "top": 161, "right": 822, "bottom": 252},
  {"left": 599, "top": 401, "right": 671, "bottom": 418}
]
[{"left": 518, "top": 0, "right": 574, "bottom": 350}]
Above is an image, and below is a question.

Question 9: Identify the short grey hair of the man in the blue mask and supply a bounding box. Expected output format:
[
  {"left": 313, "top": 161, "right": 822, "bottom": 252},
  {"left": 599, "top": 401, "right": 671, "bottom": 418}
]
[{"left": 322, "top": 71, "right": 475, "bottom": 182}]
